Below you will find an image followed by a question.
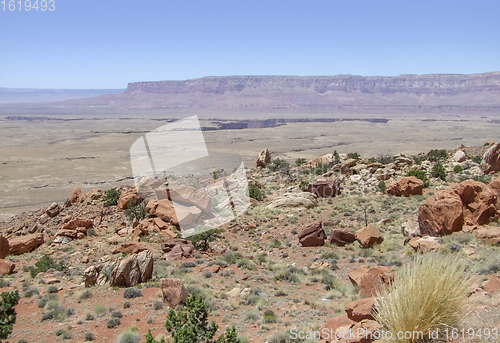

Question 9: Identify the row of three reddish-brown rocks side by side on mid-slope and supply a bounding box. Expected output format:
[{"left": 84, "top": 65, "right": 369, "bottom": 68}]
[{"left": 295, "top": 221, "right": 384, "bottom": 249}]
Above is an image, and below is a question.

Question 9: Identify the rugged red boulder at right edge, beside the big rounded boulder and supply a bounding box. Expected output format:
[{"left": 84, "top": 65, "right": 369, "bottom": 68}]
[{"left": 456, "top": 180, "right": 498, "bottom": 226}]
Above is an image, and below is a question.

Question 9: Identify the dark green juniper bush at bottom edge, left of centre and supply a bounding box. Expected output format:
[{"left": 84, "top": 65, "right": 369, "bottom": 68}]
[{"left": 165, "top": 294, "right": 240, "bottom": 343}]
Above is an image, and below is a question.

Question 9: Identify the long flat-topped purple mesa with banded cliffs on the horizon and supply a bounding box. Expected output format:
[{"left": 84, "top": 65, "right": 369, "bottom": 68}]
[{"left": 59, "top": 72, "right": 500, "bottom": 113}]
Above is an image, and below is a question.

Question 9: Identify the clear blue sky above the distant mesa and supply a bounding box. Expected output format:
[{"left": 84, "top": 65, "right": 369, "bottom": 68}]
[{"left": 0, "top": 0, "right": 500, "bottom": 88}]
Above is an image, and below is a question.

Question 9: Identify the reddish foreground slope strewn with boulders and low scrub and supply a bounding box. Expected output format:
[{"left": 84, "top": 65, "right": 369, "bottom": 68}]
[{"left": 0, "top": 143, "right": 500, "bottom": 343}]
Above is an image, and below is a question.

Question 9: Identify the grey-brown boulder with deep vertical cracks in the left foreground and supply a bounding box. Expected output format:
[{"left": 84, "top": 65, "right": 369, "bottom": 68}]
[{"left": 109, "top": 250, "right": 153, "bottom": 287}]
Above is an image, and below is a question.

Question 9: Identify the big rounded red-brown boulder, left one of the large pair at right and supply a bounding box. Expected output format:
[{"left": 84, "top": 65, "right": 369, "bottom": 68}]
[{"left": 418, "top": 190, "right": 464, "bottom": 236}]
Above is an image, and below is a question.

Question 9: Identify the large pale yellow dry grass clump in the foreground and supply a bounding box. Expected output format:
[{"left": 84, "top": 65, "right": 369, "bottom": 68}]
[{"left": 375, "top": 253, "right": 473, "bottom": 342}]
